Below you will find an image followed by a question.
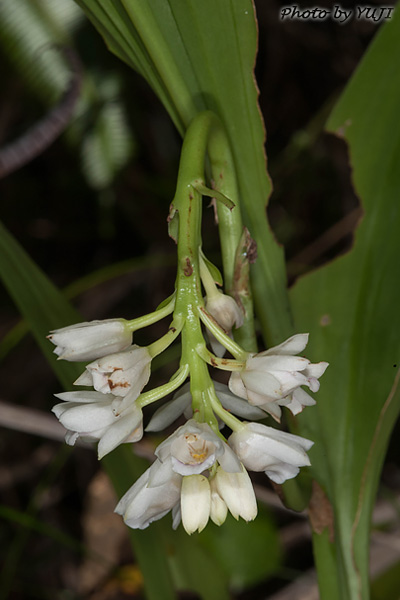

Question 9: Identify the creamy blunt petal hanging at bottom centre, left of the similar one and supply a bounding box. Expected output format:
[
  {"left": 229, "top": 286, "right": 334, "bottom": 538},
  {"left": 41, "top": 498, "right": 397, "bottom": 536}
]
[{"left": 181, "top": 475, "right": 211, "bottom": 535}]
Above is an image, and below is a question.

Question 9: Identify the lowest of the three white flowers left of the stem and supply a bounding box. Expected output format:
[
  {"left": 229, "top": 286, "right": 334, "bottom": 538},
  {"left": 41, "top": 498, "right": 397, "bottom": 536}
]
[{"left": 52, "top": 392, "right": 143, "bottom": 459}]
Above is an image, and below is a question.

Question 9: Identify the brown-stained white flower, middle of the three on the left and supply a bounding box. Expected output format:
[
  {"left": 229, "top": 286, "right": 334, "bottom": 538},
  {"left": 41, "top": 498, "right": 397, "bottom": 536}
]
[{"left": 74, "top": 345, "right": 151, "bottom": 410}]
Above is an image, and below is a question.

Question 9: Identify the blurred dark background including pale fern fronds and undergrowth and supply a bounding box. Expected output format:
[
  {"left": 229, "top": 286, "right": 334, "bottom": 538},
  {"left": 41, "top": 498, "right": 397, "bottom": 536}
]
[{"left": 0, "top": 0, "right": 400, "bottom": 600}]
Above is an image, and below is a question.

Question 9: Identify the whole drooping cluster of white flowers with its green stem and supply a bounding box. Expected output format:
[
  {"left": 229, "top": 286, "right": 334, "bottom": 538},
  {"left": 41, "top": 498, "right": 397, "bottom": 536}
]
[{"left": 49, "top": 112, "right": 328, "bottom": 534}]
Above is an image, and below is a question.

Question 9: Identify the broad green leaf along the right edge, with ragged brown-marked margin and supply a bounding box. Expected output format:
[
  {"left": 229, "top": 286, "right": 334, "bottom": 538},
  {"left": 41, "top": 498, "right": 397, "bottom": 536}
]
[{"left": 291, "top": 13, "right": 400, "bottom": 599}]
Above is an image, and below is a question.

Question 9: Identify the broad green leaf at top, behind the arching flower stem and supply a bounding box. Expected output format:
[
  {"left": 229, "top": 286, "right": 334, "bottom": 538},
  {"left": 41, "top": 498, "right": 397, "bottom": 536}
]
[{"left": 72, "top": 0, "right": 291, "bottom": 343}]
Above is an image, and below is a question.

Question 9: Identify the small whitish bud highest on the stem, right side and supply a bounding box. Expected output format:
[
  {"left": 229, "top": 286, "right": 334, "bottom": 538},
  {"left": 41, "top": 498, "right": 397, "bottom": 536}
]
[{"left": 205, "top": 290, "right": 243, "bottom": 356}]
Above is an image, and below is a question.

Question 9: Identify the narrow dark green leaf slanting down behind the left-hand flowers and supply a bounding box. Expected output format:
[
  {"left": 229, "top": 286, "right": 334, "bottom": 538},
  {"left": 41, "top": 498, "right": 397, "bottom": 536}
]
[{"left": 0, "top": 225, "right": 176, "bottom": 600}]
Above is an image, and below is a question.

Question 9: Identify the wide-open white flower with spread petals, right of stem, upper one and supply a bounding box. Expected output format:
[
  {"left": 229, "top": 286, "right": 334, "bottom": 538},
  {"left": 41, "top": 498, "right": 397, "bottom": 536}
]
[{"left": 229, "top": 333, "right": 328, "bottom": 421}]
